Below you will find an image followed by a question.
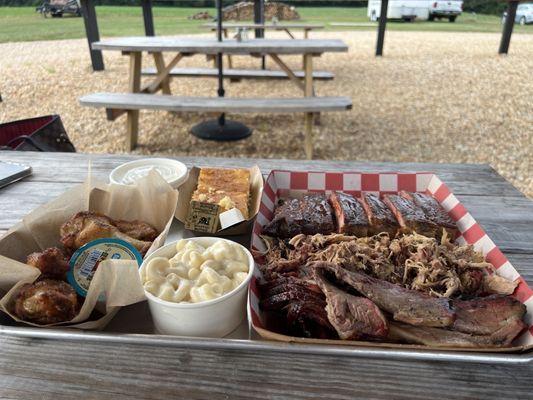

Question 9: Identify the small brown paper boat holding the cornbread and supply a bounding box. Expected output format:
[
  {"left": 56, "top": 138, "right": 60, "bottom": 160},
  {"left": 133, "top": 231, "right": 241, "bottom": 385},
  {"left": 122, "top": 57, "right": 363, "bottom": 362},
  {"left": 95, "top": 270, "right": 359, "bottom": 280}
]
[{"left": 176, "top": 165, "right": 264, "bottom": 236}]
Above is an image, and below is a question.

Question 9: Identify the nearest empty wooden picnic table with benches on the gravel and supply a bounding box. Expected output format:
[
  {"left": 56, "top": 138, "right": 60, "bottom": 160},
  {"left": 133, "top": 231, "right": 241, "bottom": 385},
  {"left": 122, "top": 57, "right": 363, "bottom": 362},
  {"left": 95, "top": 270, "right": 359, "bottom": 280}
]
[{"left": 80, "top": 37, "right": 351, "bottom": 158}]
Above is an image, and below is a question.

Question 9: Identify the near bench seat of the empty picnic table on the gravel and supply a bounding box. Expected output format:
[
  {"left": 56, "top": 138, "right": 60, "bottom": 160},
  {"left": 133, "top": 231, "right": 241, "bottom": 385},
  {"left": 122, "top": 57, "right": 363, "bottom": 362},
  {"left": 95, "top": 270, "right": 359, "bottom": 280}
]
[{"left": 79, "top": 93, "right": 352, "bottom": 114}]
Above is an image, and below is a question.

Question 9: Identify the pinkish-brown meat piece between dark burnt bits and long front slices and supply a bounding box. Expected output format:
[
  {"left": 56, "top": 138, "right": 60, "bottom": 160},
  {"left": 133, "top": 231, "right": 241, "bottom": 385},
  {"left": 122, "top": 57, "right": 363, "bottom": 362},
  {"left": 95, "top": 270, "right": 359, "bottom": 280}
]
[{"left": 315, "top": 270, "right": 389, "bottom": 340}]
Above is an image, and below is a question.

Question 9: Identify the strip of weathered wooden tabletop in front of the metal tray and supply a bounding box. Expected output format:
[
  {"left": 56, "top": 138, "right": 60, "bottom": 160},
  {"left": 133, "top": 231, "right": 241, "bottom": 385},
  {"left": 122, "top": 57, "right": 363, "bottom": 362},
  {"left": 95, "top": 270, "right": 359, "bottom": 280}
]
[{"left": 0, "top": 337, "right": 533, "bottom": 400}]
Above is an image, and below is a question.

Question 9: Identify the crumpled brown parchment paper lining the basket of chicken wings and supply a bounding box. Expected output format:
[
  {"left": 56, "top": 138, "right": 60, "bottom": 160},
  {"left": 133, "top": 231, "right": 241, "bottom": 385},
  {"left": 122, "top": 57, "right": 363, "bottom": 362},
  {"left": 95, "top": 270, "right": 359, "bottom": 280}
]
[{"left": 0, "top": 171, "right": 178, "bottom": 329}]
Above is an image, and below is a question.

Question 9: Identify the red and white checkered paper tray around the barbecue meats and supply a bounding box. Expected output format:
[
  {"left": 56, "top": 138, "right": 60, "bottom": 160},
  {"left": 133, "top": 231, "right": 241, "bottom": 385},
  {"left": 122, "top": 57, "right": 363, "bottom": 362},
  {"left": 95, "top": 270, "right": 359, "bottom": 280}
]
[{"left": 248, "top": 170, "right": 533, "bottom": 346}]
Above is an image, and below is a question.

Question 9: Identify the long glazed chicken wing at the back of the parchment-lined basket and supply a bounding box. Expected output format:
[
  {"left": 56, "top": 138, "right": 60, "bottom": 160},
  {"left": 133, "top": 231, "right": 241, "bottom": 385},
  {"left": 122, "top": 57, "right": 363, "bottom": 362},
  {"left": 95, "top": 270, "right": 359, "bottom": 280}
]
[{"left": 59, "top": 211, "right": 158, "bottom": 255}]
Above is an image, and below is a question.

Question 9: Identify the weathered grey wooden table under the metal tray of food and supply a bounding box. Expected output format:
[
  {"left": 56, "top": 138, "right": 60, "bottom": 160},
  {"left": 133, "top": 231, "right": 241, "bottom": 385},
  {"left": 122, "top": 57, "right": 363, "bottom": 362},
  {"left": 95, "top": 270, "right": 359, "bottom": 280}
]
[{"left": 0, "top": 151, "right": 533, "bottom": 400}]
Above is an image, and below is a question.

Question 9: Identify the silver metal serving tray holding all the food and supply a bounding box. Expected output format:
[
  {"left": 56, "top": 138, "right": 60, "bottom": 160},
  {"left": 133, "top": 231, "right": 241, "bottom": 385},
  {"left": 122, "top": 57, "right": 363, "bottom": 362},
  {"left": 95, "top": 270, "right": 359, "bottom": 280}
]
[{"left": 0, "top": 220, "right": 533, "bottom": 364}]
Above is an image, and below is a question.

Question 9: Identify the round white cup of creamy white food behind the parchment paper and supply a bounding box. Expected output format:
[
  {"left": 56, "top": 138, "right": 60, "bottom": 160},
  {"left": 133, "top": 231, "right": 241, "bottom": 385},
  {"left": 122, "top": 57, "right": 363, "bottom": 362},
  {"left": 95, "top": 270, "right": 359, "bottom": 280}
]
[{"left": 109, "top": 158, "right": 189, "bottom": 189}]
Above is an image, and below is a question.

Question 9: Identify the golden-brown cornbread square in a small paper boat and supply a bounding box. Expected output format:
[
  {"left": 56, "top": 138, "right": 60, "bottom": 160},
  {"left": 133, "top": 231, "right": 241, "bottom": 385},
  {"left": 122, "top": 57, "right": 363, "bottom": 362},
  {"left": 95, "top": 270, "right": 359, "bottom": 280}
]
[{"left": 192, "top": 168, "right": 250, "bottom": 219}]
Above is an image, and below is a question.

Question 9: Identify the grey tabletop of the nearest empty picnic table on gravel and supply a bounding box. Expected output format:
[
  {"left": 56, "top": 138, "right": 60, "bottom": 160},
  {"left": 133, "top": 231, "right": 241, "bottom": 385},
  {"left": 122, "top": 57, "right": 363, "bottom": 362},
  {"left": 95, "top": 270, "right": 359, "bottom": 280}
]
[{"left": 92, "top": 36, "right": 348, "bottom": 54}]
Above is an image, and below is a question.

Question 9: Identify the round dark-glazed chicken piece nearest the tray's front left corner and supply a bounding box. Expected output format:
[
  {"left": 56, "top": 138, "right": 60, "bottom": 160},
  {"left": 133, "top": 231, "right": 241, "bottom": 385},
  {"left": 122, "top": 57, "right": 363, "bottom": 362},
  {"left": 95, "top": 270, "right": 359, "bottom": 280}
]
[{"left": 15, "top": 279, "right": 78, "bottom": 325}]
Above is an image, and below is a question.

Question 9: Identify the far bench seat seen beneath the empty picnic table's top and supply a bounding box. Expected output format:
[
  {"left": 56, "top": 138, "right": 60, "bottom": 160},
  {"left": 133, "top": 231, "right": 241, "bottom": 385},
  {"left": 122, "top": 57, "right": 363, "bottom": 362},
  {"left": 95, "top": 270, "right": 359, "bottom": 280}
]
[{"left": 142, "top": 68, "right": 335, "bottom": 80}]
